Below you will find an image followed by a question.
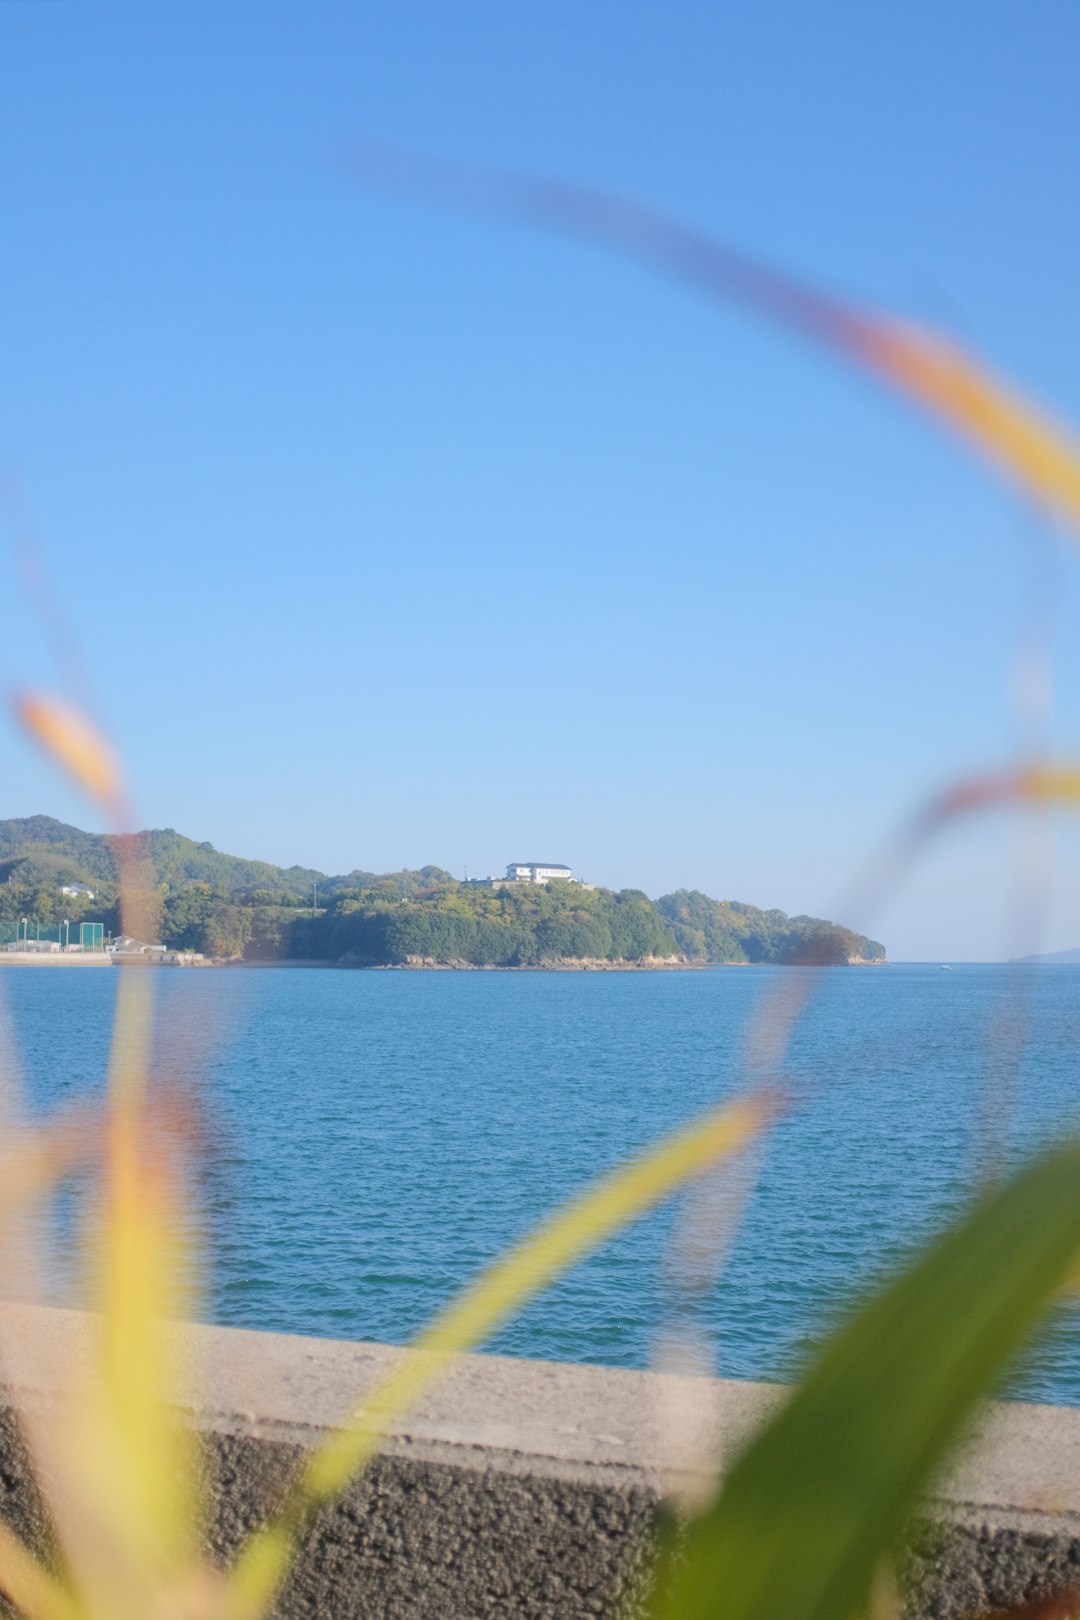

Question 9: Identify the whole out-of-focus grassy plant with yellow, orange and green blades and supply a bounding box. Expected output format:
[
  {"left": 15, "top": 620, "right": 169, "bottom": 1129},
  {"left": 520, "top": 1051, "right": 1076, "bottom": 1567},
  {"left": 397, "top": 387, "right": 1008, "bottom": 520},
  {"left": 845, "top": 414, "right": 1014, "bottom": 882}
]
[{"left": 0, "top": 180, "right": 1080, "bottom": 1620}]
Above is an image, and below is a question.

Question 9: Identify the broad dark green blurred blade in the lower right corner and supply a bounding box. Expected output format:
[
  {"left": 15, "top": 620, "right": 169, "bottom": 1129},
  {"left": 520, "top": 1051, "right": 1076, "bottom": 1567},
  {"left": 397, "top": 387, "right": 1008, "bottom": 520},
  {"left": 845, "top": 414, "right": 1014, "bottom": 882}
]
[{"left": 651, "top": 1139, "right": 1080, "bottom": 1620}]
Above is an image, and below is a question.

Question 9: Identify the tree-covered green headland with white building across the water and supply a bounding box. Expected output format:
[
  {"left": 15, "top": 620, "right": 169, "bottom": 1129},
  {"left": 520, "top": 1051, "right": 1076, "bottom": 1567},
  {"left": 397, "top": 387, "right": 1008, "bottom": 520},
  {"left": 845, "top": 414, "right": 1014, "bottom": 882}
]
[{"left": 0, "top": 816, "right": 886, "bottom": 967}]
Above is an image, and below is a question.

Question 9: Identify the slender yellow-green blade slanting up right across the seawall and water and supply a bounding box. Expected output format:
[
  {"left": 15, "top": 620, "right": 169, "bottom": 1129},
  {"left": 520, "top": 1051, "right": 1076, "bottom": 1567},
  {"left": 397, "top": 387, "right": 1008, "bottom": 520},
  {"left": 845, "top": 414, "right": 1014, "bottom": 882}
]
[{"left": 232, "top": 1094, "right": 777, "bottom": 1617}]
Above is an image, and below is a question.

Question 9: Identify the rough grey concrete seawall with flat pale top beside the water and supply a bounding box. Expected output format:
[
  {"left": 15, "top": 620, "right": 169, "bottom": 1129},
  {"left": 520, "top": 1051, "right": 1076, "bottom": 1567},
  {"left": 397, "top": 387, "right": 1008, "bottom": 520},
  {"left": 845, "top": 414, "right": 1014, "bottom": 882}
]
[{"left": 0, "top": 1306, "right": 1080, "bottom": 1620}]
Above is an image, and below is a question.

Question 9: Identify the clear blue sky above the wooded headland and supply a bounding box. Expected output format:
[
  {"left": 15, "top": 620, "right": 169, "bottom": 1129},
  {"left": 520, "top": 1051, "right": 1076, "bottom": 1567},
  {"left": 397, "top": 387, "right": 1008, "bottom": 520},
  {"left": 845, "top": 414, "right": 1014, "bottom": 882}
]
[{"left": 0, "top": 0, "right": 1080, "bottom": 959}]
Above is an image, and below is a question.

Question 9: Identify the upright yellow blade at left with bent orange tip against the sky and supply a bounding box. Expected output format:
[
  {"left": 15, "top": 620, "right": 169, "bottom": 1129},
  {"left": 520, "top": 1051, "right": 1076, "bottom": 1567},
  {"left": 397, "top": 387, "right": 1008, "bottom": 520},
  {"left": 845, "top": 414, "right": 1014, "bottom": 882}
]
[{"left": 9, "top": 693, "right": 196, "bottom": 1620}]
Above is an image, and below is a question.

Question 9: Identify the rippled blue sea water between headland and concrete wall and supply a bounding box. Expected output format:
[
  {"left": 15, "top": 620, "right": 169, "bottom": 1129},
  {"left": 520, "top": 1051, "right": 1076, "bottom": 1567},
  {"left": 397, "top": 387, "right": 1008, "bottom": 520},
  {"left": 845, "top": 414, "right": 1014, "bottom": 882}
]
[{"left": 0, "top": 966, "right": 1080, "bottom": 1405}]
